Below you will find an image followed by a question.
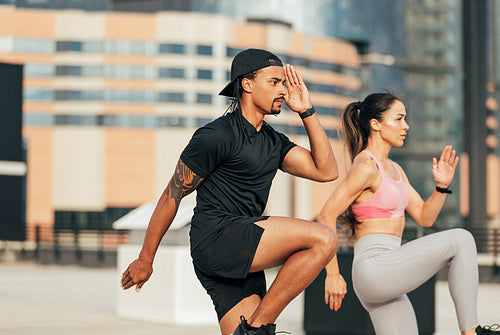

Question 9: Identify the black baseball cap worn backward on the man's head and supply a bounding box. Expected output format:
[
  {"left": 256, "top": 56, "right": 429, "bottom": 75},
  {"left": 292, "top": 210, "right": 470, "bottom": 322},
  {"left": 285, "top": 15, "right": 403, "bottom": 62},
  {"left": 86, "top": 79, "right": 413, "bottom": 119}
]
[{"left": 219, "top": 49, "right": 283, "bottom": 97}]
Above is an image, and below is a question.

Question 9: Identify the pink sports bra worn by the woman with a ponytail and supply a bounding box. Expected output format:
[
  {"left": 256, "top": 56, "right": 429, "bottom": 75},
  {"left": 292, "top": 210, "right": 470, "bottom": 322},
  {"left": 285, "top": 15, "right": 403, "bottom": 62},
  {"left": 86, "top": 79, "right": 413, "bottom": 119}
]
[{"left": 351, "top": 150, "right": 410, "bottom": 221}]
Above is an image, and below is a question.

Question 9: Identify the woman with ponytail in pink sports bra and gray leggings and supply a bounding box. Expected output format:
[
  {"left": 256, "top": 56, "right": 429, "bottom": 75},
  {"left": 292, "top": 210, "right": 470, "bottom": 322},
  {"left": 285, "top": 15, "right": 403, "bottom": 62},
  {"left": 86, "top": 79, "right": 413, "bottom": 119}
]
[{"left": 317, "top": 93, "right": 500, "bottom": 335}]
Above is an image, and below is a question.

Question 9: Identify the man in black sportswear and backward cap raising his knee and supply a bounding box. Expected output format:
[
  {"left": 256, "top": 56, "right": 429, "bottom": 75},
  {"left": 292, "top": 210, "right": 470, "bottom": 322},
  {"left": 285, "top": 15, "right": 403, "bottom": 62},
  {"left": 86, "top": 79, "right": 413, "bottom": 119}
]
[{"left": 122, "top": 49, "right": 338, "bottom": 335}]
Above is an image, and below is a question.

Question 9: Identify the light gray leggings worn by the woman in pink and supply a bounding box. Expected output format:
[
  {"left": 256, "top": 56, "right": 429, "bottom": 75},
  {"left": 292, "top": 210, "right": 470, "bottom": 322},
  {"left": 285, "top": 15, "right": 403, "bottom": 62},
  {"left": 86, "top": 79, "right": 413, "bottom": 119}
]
[{"left": 352, "top": 229, "right": 478, "bottom": 335}]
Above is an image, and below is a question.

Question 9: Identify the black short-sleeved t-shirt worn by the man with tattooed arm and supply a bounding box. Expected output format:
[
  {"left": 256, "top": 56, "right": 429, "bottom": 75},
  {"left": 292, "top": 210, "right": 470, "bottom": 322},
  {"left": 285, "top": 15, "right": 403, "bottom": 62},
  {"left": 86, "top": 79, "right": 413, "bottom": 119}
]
[{"left": 180, "top": 110, "right": 295, "bottom": 247}]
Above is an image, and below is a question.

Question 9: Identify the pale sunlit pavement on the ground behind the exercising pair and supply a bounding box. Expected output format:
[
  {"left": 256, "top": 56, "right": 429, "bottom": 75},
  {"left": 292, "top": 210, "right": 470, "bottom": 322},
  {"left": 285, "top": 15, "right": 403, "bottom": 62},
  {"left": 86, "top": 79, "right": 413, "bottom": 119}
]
[{"left": 0, "top": 263, "right": 500, "bottom": 335}]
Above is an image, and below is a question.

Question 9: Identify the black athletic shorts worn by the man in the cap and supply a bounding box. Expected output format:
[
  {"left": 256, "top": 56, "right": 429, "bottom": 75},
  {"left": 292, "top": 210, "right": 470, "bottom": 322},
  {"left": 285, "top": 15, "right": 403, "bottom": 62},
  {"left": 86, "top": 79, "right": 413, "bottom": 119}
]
[{"left": 191, "top": 216, "right": 268, "bottom": 320}]
